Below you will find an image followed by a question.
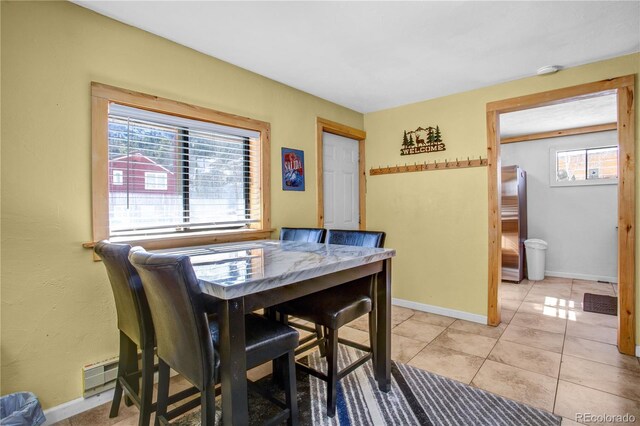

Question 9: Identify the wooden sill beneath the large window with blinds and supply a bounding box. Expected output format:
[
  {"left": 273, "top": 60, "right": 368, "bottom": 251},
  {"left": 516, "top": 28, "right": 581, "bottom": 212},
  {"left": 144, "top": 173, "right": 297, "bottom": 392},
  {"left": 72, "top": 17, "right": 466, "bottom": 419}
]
[{"left": 82, "top": 229, "right": 273, "bottom": 260}]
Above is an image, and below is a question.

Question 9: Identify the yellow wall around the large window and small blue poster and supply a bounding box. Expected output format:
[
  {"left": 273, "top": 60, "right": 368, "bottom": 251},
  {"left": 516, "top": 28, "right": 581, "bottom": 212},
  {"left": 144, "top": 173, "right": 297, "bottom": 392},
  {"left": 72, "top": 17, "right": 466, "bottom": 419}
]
[{"left": 1, "top": 1, "right": 363, "bottom": 407}]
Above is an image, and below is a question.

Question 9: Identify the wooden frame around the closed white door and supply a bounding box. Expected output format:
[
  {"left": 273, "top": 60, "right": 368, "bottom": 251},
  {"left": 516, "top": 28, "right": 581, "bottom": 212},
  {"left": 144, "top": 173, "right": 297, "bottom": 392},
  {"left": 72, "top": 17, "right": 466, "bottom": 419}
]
[{"left": 316, "top": 117, "right": 367, "bottom": 230}]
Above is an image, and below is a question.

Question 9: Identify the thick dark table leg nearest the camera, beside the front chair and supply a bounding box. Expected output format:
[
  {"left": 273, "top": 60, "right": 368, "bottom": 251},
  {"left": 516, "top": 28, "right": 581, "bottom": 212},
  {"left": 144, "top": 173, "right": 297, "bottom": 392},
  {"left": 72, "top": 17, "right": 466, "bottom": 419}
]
[{"left": 218, "top": 298, "right": 249, "bottom": 425}]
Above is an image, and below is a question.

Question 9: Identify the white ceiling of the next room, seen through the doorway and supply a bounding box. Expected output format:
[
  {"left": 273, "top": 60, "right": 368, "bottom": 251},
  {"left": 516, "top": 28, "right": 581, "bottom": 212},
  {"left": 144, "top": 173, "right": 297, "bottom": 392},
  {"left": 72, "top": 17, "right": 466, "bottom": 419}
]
[{"left": 500, "top": 95, "right": 618, "bottom": 138}]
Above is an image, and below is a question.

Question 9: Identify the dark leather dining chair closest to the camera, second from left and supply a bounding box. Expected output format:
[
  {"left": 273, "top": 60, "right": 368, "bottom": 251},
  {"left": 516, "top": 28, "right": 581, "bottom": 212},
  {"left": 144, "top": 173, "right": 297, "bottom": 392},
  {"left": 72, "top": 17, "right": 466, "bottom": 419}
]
[{"left": 129, "top": 247, "right": 298, "bottom": 425}]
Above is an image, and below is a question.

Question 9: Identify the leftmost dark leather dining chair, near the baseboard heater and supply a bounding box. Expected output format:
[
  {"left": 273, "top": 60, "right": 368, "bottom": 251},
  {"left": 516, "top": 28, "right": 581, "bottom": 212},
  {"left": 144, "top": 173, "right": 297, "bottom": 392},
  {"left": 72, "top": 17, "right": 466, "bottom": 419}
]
[{"left": 94, "top": 240, "right": 198, "bottom": 426}]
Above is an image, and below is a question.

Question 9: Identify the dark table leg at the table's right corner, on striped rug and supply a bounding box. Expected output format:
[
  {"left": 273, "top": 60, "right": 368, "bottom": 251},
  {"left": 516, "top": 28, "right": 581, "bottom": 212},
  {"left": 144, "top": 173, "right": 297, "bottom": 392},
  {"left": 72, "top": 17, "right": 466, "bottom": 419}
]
[{"left": 374, "top": 259, "right": 391, "bottom": 392}]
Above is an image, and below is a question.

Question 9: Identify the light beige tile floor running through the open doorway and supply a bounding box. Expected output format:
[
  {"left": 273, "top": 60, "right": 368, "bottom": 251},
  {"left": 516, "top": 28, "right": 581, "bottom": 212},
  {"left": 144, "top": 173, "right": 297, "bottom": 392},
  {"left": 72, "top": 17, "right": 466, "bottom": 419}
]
[{"left": 60, "top": 278, "right": 640, "bottom": 426}]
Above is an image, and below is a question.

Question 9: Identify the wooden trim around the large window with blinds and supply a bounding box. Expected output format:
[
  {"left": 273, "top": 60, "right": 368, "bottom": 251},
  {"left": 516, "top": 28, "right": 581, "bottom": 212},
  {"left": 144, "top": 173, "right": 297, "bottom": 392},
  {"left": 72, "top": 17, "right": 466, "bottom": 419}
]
[{"left": 83, "top": 82, "right": 272, "bottom": 256}]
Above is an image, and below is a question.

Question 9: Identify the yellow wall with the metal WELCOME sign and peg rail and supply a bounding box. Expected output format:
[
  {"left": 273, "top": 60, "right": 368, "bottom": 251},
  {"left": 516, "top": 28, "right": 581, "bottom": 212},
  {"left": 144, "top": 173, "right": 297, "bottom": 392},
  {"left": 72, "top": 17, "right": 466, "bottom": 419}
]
[{"left": 365, "top": 54, "right": 640, "bottom": 326}]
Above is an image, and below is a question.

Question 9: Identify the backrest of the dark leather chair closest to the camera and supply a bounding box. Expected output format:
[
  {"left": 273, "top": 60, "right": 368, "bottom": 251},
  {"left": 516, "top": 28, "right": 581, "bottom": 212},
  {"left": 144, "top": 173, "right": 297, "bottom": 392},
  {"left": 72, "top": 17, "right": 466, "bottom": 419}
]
[{"left": 129, "top": 247, "right": 215, "bottom": 390}]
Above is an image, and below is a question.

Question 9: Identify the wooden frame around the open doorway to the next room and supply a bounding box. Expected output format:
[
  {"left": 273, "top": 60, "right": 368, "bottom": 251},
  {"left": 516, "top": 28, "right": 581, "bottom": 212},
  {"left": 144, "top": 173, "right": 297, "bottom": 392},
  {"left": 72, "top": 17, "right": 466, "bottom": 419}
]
[{"left": 487, "top": 75, "right": 636, "bottom": 355}]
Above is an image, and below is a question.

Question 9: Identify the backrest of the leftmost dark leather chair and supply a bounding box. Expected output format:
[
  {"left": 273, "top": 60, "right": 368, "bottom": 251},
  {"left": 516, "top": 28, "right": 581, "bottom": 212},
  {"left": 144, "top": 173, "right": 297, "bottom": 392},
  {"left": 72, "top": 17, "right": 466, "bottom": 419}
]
[{"left": 93, "top": 240, "right": 154, "bottom": 348}]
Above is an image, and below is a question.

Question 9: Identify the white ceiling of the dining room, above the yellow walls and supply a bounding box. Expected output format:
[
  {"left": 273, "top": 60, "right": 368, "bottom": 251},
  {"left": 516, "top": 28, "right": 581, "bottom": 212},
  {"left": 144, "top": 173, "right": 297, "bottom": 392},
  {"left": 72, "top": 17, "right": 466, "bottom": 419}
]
[{"left": 75, "top": 1, "right": 640, "bottom": 112}]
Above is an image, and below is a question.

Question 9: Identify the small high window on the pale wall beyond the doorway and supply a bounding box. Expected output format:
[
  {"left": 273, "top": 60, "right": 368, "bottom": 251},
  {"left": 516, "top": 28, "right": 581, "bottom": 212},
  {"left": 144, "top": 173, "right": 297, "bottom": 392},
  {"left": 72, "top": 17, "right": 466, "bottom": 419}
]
[{"left": 549, "top": 146, "right": 618, "bottom": 186}]
